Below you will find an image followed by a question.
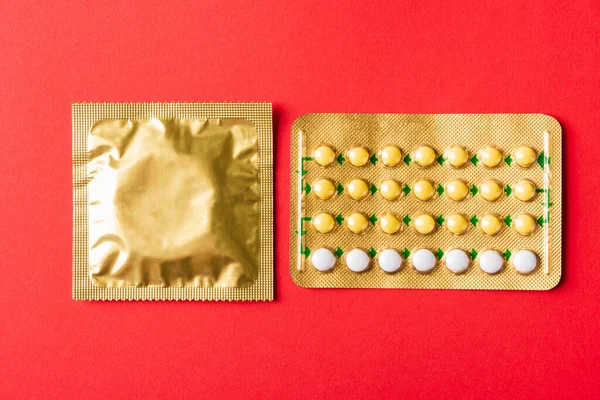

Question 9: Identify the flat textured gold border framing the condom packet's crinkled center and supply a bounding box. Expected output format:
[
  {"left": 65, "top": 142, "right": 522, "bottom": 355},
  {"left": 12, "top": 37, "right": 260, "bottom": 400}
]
[{"left": 72, "top": 103, "right": 273, "bottom": 300}]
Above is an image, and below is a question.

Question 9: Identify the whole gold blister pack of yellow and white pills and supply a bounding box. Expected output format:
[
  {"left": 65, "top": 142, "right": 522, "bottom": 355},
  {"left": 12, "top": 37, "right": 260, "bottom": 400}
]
[{"left": 290, "top": 114, "right": 562, "bottom": 290}]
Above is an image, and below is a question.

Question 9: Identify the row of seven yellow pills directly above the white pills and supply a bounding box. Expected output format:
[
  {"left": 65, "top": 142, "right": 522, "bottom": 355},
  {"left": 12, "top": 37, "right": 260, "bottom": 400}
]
[{"left": 311, "top": 212, "right": 537, "bottom": 236}]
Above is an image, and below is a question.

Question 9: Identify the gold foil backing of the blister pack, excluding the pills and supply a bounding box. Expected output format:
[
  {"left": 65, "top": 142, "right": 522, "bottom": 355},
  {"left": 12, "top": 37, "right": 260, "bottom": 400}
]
[{"left": 290, "top": 114, "right": 562, "bottom": 290}]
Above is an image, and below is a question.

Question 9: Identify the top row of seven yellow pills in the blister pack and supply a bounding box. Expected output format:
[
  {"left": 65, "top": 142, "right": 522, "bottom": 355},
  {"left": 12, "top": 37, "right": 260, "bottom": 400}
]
[{"left": 312, "top": 144, "right": 538, "bottom": 168}]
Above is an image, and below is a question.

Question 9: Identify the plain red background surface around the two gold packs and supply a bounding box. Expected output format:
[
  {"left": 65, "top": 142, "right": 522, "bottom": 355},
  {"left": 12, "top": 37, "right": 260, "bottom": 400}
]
[{"left": 0, "top": 0, "right": 600, "bottom": 399}]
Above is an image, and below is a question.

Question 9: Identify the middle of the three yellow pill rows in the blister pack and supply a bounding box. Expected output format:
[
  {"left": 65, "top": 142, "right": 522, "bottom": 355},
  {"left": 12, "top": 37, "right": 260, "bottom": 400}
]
[{"left": 312, "top": 178, "right": 537, "bottom": 202}]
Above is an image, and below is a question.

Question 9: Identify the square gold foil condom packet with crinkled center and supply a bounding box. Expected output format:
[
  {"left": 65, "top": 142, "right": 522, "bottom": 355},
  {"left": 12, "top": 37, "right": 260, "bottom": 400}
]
[{"left": 72, "top": 103, "right": 273, "bottom": 300}]
